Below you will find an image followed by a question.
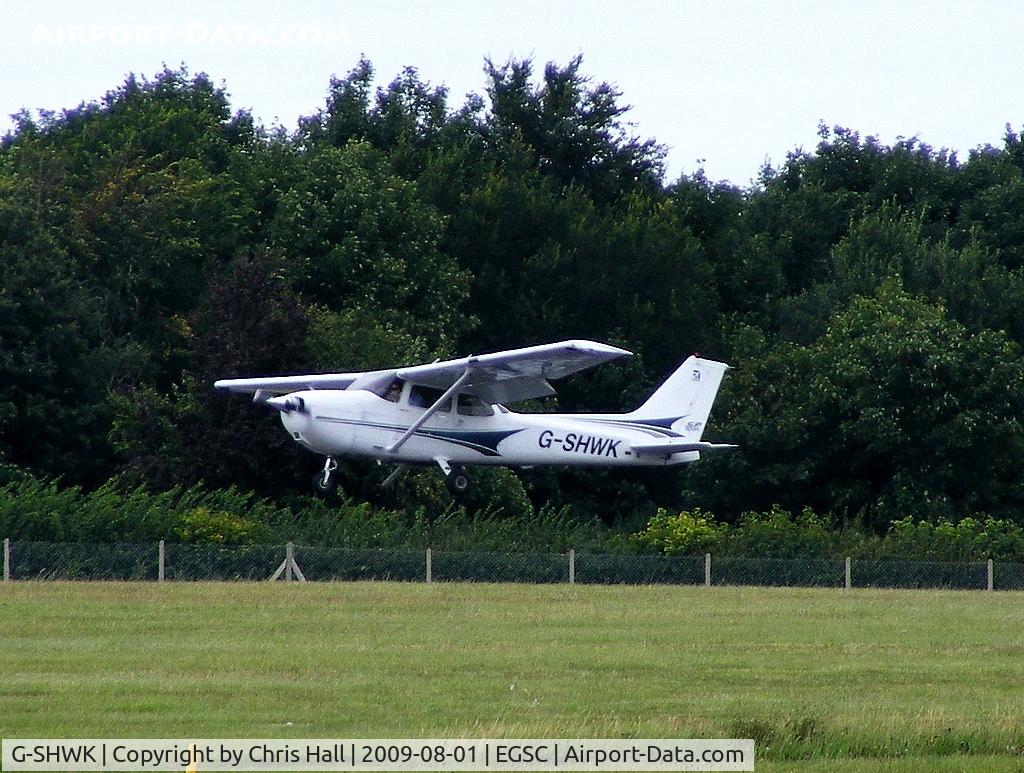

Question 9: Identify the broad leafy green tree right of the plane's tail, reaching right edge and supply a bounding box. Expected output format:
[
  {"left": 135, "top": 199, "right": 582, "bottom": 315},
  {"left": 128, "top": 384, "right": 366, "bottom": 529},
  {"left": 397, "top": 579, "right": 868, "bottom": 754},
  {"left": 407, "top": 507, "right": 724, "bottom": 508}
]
[{"left": 692, "top": 283, "right": 1024, "bottom": 525}]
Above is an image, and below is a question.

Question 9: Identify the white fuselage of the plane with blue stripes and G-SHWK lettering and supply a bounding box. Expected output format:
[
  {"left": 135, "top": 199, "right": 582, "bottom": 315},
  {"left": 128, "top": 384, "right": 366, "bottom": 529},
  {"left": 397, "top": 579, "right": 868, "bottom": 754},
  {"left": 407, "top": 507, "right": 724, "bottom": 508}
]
[{"left": 281, "top": 387, "right": 700, "bottom": 467}]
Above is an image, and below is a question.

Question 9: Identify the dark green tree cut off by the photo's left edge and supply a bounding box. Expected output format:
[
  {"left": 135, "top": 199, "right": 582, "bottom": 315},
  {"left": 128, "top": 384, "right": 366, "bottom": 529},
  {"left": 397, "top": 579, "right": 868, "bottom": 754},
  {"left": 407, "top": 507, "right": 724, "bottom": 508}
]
[{"left": 0, "top": 175, "right": 117, "bottom": 482}]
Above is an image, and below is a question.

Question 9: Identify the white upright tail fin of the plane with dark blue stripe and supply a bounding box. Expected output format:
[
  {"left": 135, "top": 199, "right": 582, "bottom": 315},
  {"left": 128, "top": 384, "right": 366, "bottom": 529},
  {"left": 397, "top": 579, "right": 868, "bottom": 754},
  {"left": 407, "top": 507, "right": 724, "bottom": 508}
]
[{"left": 630, "top": 355, "right": 729, "bottom": 440}]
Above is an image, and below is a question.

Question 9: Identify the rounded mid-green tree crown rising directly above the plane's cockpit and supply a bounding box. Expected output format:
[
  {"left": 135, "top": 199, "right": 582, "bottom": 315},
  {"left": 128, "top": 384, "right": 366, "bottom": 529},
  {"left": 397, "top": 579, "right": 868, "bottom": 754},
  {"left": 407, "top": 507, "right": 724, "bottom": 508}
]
[{"left": 269, "top": 143, "right": 472, "bottom": 350}]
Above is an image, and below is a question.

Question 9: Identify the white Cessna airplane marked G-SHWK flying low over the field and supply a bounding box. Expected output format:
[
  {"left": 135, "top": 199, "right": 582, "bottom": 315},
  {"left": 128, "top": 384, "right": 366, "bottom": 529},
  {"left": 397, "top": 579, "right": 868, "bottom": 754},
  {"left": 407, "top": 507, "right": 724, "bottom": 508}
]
[{"left": 214, "top": 341, "right": 736, "bottom": 493}]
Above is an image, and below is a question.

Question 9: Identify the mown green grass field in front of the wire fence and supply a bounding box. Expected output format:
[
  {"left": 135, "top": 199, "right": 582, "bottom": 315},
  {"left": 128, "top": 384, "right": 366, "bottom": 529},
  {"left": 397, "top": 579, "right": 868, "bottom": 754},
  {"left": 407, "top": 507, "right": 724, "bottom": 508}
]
[{"left": 0, "top": 583, "right": 1024, "bottom": 771}]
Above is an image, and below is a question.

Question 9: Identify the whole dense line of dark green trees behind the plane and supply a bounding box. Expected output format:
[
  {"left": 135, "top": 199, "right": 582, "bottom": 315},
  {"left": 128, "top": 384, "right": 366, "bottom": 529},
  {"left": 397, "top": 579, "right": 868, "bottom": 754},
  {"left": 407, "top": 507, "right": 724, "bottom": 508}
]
[{"left": 0, "top": 57, "right": 1024, "bottom": 533}]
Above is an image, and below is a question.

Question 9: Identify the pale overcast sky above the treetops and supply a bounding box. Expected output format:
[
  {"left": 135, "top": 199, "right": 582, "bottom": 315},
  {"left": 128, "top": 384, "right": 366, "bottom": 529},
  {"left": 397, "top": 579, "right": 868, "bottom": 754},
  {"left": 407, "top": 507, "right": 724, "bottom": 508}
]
[{"left": 0, "top": 0, "right": 1024, "bottom": 185}]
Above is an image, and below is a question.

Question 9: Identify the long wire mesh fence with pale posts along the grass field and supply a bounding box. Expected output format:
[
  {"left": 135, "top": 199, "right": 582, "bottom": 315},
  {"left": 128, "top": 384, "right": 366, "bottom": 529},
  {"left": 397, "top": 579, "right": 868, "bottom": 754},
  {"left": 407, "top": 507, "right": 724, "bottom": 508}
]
[{"left": 3, "top": 540, "right": 1024, "bottom": 591}]
